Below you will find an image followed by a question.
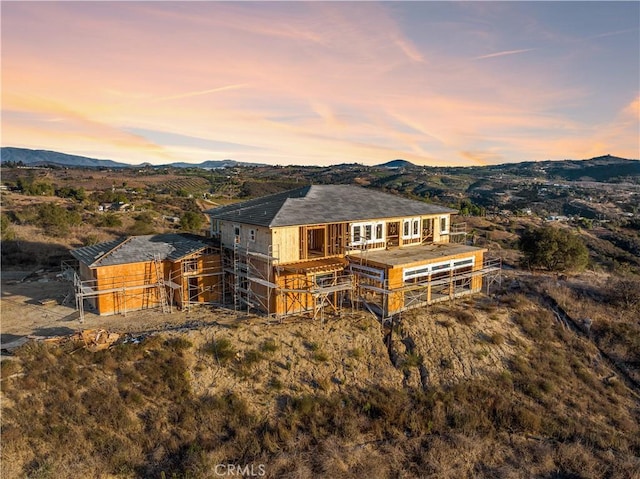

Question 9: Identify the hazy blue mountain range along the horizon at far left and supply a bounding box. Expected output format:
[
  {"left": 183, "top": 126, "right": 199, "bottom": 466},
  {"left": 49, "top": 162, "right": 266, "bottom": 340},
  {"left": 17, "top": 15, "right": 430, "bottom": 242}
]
[{"left": 0, "top": 147, "right": 263, "bottom": 169}]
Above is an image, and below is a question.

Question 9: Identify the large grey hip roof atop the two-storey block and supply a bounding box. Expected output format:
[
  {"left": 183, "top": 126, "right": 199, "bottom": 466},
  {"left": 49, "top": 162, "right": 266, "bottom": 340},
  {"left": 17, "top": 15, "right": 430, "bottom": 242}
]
[{"left": 207, "top": 185, "right": 457, "bottom": 227}]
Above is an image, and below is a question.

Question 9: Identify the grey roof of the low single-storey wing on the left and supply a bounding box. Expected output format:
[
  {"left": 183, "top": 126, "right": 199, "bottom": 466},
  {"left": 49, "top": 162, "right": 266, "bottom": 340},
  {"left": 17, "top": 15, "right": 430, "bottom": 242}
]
[{"left": 71, "top": 233, "right": 208, "bottom": 268}]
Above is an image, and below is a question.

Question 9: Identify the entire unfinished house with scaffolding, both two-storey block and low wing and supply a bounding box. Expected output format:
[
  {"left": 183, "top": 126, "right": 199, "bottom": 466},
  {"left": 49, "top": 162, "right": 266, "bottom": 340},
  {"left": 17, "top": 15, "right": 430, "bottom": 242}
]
[{"left": 72, "top": 185, "right": 500, "bottom": 318}]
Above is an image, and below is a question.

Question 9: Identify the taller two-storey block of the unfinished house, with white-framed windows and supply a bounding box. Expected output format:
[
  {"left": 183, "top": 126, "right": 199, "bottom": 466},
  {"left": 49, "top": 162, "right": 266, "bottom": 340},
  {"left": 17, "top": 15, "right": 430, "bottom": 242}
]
[{"left": 207, "top": 185, "right": 500, "bottom": 318}]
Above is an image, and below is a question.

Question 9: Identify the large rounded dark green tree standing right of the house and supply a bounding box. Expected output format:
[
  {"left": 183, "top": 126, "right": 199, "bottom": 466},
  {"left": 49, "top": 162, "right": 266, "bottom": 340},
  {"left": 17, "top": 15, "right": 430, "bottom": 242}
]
[{"left": 520, "top": 226, "right": 589, "bottom": 271}]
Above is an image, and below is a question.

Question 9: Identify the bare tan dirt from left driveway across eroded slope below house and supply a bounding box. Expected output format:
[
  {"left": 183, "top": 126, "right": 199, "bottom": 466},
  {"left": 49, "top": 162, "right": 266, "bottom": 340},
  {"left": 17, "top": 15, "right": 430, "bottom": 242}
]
[{"left": 0, "top": 266, "right": 523, "bottom": 404}]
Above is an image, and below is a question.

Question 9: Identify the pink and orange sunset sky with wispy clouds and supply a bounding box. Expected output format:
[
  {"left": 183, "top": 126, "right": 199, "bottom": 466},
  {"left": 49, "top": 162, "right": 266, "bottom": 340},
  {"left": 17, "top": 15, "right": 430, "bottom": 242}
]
[{"left": 1, "top": 1, "right": 640, "bottom": 166}]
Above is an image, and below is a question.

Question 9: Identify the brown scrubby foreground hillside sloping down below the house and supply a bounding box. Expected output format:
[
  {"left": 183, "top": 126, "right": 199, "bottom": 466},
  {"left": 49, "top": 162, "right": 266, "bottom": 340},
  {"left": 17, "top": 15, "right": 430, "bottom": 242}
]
[{"left": 2, "top": 287, "right": 640, "bottom": 478}]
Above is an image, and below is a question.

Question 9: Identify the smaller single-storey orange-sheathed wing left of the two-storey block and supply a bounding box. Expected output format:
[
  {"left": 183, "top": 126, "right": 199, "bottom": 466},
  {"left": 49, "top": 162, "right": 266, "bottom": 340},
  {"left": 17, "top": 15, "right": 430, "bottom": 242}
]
[{"left": 71, "top": 234, "right": 224, "bottom": 319}]
